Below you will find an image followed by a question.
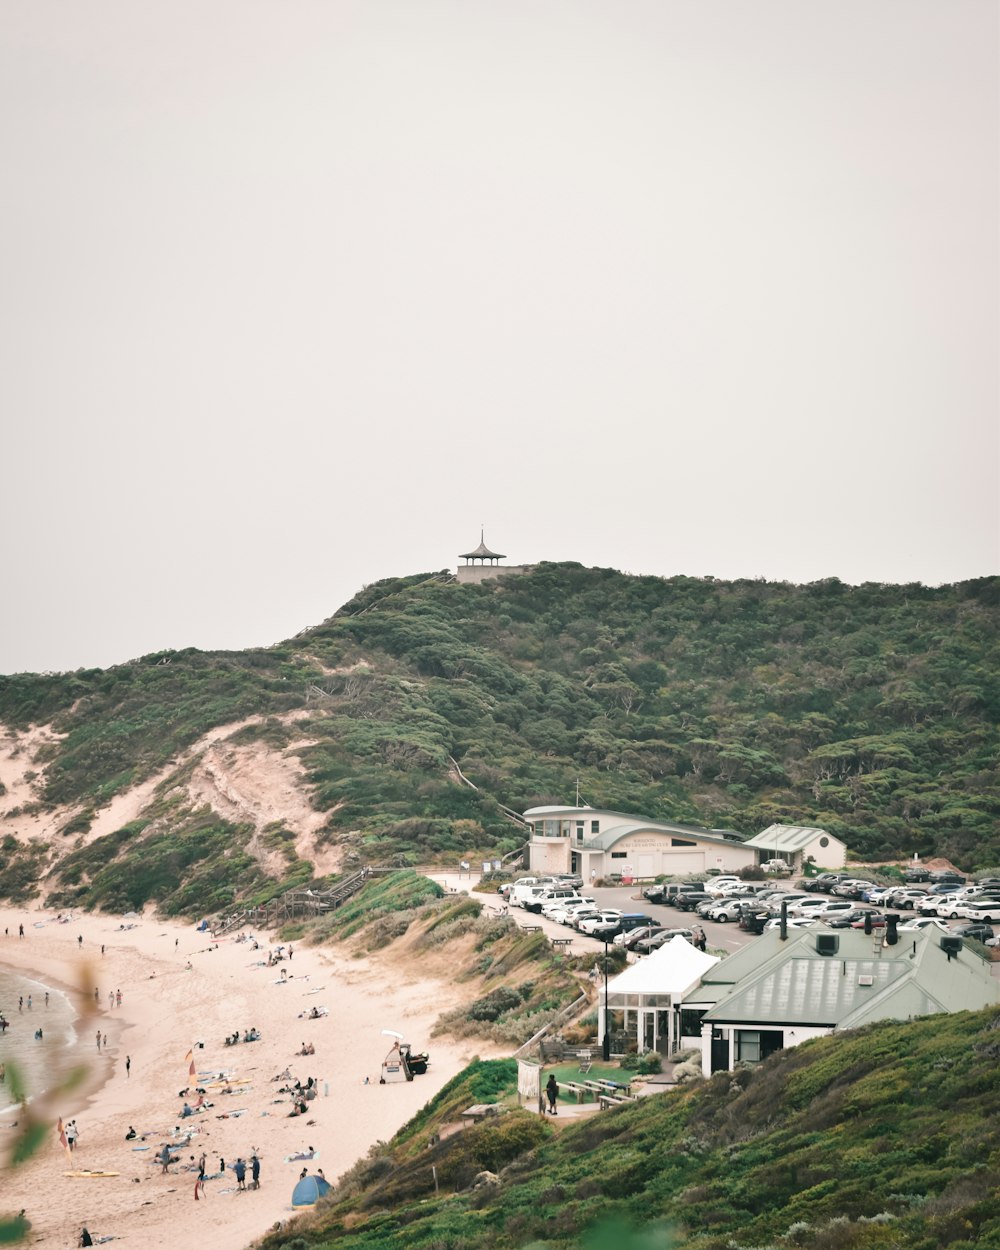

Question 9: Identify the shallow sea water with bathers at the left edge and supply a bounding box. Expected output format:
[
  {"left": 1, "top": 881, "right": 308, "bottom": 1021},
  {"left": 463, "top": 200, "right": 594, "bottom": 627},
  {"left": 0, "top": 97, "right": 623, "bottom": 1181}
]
[{"left": 0, "top": 965, "right": 76, "bottom": 1114}]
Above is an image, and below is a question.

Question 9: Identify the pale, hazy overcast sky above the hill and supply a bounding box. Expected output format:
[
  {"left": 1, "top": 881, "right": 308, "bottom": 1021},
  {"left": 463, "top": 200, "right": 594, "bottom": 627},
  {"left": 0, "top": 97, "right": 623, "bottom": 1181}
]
[{"left": 0, "top": 0, "right": 1000, "bottom": 673}]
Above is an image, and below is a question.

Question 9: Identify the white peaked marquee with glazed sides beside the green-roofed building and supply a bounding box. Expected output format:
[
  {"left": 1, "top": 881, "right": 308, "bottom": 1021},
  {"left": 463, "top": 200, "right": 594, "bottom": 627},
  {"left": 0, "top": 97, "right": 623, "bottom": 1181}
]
[{"left": 598, "top": 934, "right": 719, "bottom": 1055}]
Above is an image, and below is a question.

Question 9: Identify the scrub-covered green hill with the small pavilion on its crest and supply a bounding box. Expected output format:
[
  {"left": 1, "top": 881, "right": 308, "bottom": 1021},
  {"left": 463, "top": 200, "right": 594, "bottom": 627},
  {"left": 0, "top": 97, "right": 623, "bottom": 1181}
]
[{"left": 0, "top": 565, "right": 1000, "bottom": 910}]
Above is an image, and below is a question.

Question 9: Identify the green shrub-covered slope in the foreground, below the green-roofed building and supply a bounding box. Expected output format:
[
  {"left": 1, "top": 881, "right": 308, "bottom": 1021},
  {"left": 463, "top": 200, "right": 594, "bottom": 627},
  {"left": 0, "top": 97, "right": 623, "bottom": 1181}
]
[{"left": 261, "top": 1009, "right": 1000, "bottom": 1250}]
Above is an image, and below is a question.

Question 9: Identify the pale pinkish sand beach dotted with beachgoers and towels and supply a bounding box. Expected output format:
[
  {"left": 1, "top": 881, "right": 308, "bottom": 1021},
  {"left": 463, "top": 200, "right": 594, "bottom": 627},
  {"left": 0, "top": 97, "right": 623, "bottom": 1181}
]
[{"left": 0, "top": 908, "right": 490, "bottom": 1250}]
